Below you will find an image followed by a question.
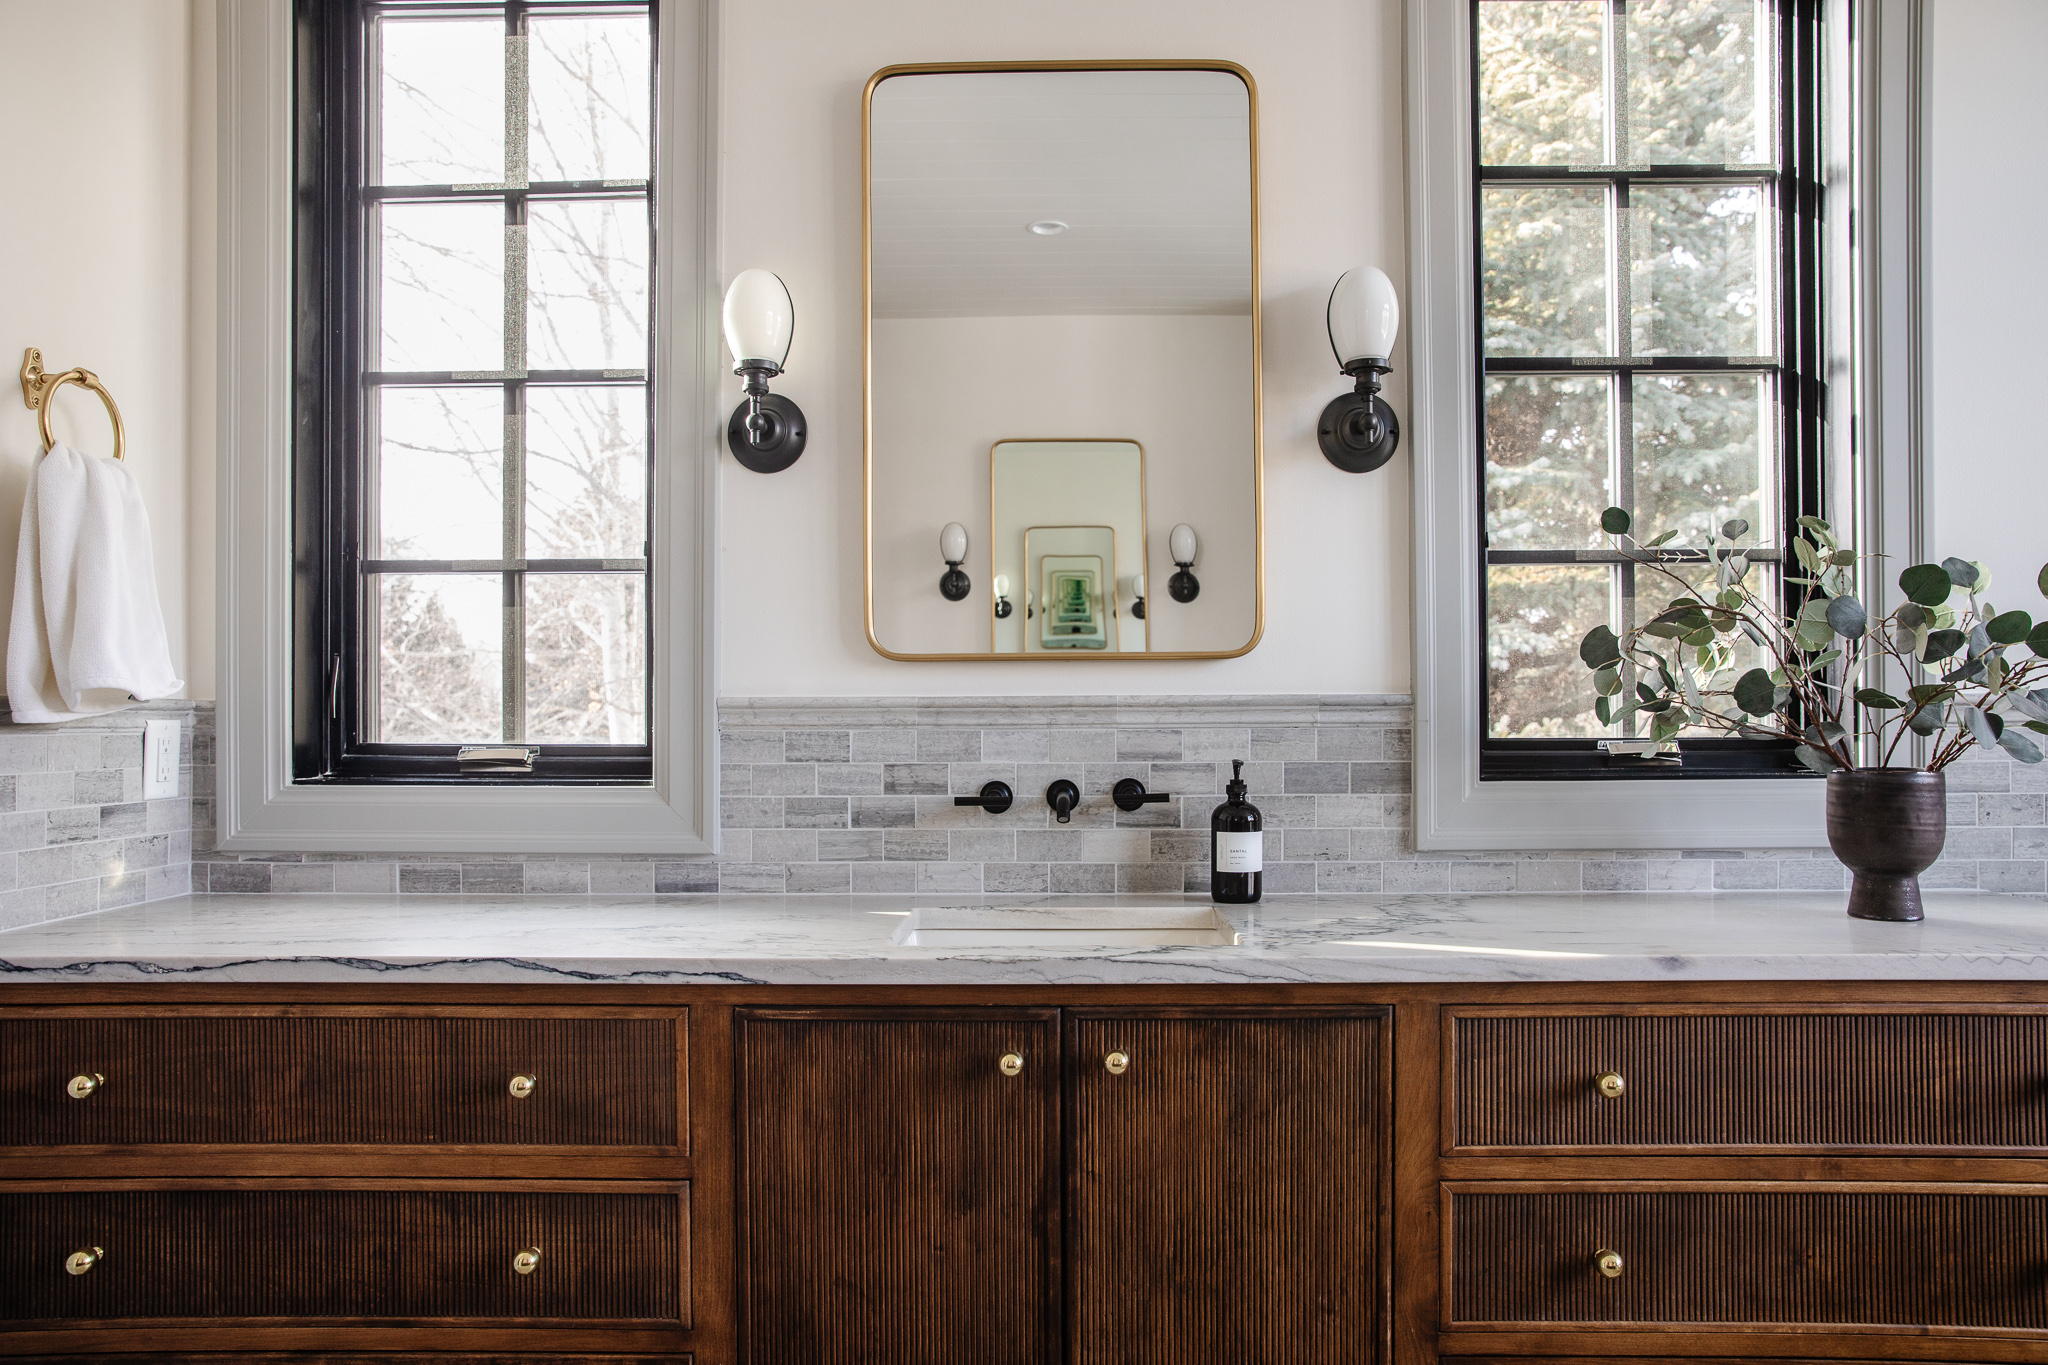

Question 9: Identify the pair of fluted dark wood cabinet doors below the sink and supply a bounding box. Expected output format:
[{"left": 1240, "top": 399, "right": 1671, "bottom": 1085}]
[{"left": 735, "top": 1009, "right": 1391, "bottom": 1365}]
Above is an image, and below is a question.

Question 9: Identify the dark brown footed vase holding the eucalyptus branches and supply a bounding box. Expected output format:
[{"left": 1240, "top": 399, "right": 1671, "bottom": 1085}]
[{"left": 1827, "top": 767, "right": 1948, "bottom": 919}]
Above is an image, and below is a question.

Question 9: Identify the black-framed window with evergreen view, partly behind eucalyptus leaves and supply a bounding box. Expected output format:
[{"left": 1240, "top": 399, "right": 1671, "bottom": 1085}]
[{"left": 1470, "top": 0, "right": 1825, "bottom": 780}]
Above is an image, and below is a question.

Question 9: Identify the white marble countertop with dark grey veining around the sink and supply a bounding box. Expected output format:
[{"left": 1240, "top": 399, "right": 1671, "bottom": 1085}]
[{"left": 0, "top": 892, "right": 2048, "bottom": 986}]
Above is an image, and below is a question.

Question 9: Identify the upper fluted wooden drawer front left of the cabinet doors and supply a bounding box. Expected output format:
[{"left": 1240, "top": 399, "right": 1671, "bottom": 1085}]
[{"left": 0, "top": 1009, "right": 684, "bottom": 1148}]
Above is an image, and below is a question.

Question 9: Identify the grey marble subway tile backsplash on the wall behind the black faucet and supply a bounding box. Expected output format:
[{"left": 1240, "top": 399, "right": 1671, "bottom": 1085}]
[{"left": 180, "top": 696, "right": 2048, "bottom": 896}]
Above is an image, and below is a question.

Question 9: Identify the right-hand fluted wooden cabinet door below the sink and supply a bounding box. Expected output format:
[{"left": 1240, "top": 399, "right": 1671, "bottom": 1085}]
[{"left": 1067, "top": 1009, "right": 1391, "bottom": 1365}]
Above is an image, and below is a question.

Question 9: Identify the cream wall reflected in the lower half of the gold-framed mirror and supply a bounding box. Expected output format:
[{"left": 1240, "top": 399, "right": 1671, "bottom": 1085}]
[{"left": 868, "top": 315, "right": 1255, "bottom": 671}]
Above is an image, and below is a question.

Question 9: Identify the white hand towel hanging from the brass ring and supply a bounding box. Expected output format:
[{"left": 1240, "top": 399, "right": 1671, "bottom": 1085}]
[{"left": 6, "top": 442, "right": 184, "bottom": 724}]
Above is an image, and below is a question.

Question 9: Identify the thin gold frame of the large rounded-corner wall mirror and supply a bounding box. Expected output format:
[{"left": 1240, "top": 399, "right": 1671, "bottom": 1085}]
[{"left": 860, "top": 57, "right": 1266, "bottom": 663}]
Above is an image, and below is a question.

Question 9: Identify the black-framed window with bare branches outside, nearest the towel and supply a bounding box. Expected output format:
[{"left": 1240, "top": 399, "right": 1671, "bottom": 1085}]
[{"left": 293, "top": 0, "right": 657, "bottom": 784}]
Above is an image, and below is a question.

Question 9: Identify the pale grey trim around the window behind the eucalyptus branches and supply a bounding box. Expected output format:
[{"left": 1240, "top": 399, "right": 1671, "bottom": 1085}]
[{"left": 1407, "top": 0, "right": 1925, "bottom": 849}]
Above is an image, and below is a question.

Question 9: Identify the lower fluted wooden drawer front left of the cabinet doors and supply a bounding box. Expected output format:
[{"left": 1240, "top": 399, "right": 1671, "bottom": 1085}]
[{"left": 0, "top": 1185, "right": 688, "bottom": 1322}]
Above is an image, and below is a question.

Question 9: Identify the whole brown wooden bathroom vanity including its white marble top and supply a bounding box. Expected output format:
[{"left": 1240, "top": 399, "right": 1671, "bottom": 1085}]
[{"left": 0, "top": 894, "right": 2048, "bottom": 1365}]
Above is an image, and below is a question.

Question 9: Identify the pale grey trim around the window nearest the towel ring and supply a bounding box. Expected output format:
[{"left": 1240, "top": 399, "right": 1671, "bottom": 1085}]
[{"left": 215, "top": 0, "right": 721, "bottom": 855}]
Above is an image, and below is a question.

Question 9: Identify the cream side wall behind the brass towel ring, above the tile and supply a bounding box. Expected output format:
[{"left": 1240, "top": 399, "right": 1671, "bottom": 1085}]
[{"left": 0, "top": 0, "right": 192, "bottom": 696}]
